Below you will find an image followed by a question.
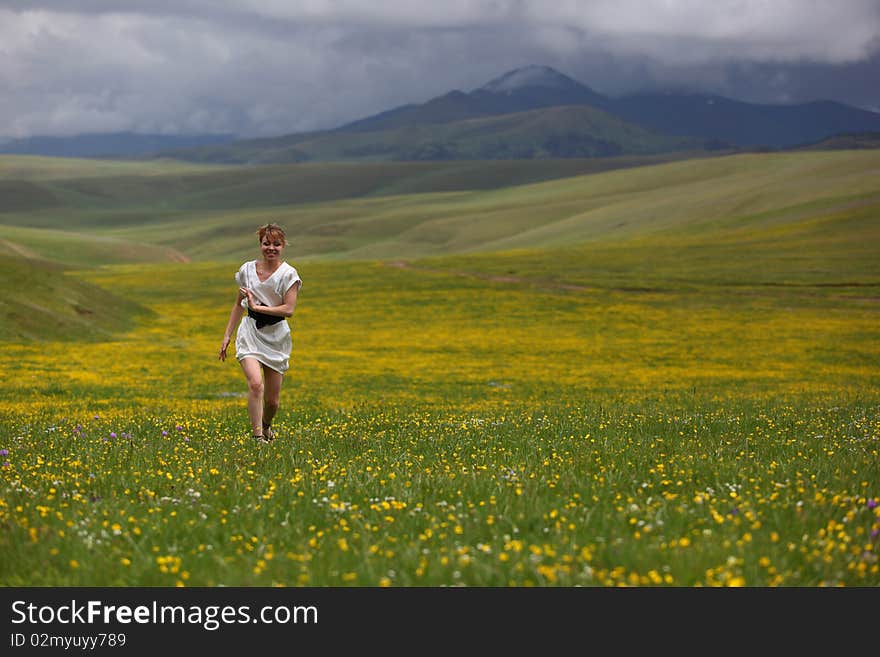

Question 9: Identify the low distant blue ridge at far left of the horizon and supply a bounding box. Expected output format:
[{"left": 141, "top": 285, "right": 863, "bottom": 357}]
[{"left": 0, "top": 132, "right": 234, "bottom": 158}]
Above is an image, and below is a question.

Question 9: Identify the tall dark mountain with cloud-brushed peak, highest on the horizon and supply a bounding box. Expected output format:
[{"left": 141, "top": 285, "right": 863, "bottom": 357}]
[{"left": 156, "top": 66, "right": 718, "bottom": 164}]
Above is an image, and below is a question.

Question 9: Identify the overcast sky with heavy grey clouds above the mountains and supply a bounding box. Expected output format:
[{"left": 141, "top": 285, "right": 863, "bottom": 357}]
[{"left": 0, "top": 0, "right": 880, "bottom": 137}]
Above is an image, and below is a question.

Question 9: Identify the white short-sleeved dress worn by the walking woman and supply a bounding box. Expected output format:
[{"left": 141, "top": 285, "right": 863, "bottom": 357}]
[{"left": 235, "top": 260, "right": 302, "bottom": 374}]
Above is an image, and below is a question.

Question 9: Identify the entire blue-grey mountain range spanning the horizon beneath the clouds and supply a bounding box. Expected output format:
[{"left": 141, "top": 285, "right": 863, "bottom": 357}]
[{"left": 6, "top": 65, "right": 880, "bottom": 164}]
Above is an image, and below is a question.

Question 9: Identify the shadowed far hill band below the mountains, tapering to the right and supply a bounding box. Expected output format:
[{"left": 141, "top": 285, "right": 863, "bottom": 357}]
[{"left": 0, "top": 154, "right": 687, "bottom": 213}]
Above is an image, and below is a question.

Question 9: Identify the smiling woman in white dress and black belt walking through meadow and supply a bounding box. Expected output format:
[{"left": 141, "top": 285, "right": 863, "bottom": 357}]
[{"left": 220, "top": 223, "right": 302, "bottom": 442}]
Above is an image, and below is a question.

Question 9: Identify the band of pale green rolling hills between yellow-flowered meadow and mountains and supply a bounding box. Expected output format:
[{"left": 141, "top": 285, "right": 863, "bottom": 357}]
[{"left": 0, "top": 150, "right": 880, "bottom": 266}]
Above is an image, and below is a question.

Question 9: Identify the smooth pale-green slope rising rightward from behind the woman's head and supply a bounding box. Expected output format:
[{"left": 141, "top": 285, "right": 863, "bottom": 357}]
[{"left": 189, "top": 152, "right": 880, "bottom": 259}]
